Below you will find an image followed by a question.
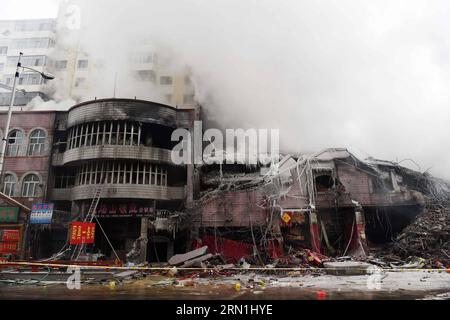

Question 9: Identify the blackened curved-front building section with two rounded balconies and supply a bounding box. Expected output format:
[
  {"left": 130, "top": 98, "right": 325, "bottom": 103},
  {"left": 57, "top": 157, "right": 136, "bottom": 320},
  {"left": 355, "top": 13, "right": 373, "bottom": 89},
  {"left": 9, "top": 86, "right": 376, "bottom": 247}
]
[{"left": 50, "top": 99, "right": 197, "bottom": 263}]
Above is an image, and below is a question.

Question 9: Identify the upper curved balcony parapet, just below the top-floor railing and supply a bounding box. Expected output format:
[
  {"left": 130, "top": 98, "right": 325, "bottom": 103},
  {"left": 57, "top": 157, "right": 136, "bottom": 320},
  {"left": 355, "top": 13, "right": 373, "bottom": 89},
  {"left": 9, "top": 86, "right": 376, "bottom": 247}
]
[{"left": 52, "top": 145, "right": 172, "bottom": 166}]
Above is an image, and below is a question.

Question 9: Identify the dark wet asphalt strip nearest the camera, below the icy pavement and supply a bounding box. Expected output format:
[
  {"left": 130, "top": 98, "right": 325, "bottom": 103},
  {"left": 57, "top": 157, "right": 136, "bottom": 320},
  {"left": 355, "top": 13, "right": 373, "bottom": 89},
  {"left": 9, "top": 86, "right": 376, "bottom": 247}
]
[{"left": 0, "top": 285, "right": 445, "bottom": 300}]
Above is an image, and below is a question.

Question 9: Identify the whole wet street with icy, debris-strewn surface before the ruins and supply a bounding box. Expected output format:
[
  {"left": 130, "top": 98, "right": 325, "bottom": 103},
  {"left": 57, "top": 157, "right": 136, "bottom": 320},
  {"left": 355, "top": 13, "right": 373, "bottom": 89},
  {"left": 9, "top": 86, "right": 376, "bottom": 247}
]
[{"left": 0, "top": 273, "right": 450, "bottom": 300}]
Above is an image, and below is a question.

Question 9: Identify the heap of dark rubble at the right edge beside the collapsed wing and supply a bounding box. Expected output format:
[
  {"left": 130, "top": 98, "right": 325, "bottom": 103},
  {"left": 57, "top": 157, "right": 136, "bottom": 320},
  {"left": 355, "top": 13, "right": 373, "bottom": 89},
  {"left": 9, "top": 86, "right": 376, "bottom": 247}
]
[{"left": 391, "top": 199, "right": 450, "bottom": 266}]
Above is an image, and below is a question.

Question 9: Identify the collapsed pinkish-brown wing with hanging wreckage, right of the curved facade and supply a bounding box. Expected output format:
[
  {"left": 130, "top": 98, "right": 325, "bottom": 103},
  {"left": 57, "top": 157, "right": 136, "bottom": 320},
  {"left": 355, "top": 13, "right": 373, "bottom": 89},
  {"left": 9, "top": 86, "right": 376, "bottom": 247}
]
[{"left": 193, "top": 148, "right": 425, "bottom": 260}]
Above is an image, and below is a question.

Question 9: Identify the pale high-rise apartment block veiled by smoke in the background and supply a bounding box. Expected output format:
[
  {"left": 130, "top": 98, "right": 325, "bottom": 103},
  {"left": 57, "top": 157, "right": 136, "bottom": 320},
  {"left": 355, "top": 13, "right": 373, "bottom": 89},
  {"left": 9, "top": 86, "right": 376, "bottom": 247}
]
[{"left": 0, "top": 2, "right": 194, "bottom": 109}]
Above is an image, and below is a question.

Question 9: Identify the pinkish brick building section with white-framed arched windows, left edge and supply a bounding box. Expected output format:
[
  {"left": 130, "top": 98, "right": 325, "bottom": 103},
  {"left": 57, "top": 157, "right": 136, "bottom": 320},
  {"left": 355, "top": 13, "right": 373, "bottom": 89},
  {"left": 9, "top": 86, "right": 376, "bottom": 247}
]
[{"left": 0, "top": 111, "right": 57, "bottom": 257}]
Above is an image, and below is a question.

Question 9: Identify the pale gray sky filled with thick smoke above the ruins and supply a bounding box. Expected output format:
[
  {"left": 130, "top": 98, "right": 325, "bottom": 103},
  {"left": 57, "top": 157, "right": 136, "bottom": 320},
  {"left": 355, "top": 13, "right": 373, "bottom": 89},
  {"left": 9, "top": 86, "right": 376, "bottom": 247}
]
[{"left": 0, "top": 0, "right": 450, "bottom": 178}]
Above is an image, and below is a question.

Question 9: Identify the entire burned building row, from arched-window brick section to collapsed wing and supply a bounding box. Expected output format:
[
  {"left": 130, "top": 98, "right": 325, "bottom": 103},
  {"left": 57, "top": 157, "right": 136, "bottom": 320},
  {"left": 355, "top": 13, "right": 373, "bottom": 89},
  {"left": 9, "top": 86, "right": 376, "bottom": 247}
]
[{"left": 0, "top": 99, "right": 438, "bottom": 263}]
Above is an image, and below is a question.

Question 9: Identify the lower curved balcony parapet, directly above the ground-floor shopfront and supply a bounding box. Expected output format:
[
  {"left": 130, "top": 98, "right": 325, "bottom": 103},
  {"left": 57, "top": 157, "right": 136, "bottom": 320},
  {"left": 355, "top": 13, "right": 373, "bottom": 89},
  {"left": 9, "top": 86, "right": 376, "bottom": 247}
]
[{"left": 50, "top": 184, "right": 185, "bottom": 201}]
